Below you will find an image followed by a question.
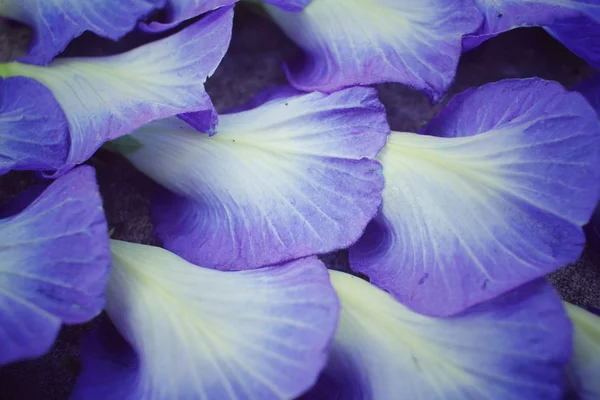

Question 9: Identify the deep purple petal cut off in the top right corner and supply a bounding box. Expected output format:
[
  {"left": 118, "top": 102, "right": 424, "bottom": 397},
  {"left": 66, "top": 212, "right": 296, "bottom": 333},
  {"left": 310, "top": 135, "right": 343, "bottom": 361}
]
[{"left": 464, "top": 0, "right": 600, "bottom": 68}]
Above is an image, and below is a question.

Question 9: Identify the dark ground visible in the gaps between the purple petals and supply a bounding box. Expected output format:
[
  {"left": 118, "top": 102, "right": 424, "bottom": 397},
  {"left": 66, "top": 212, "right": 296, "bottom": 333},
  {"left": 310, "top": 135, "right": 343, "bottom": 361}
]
[{"left": 0, "top": 5, "right": 600, "bottom": 400}]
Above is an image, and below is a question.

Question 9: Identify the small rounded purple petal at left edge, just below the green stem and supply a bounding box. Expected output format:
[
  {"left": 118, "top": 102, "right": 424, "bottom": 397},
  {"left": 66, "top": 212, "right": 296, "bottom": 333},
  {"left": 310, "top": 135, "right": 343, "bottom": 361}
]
[{"left": 0, "top": 77, "right": 69, "bottom": 174}]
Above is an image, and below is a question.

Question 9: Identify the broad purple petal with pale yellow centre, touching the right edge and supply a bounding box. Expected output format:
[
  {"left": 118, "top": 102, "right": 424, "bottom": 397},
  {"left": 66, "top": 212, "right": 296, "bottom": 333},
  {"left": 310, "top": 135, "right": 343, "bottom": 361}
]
[{"left": 350, "top": 79, "right": 600, "bottom": 315}]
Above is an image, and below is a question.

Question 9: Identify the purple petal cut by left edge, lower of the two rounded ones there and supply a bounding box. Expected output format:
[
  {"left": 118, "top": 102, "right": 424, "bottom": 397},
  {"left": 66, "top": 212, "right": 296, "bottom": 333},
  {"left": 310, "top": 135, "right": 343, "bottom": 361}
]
[{"left": 0, "top": 166, "right": 110, "bottom": 364}]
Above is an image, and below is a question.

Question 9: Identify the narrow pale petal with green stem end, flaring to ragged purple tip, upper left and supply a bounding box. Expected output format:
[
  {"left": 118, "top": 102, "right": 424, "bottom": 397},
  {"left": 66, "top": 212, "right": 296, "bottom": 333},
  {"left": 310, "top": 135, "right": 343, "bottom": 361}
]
[{"left": 0, "top": 7, "right": 233, "bottom": 172}]
